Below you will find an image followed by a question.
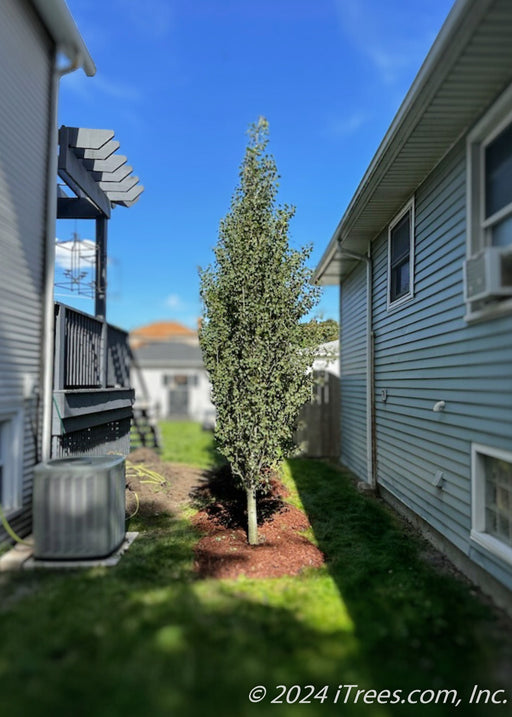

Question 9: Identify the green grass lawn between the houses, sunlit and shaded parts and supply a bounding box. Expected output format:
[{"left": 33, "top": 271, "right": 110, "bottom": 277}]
[{"left": 0, "top": 424, "right": 512, "bottom": 717}]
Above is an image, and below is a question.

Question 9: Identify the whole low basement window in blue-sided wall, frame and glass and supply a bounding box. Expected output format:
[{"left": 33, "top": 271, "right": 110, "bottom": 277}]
[{"left": 471, "top": 444, "right": 512, "bottom": 563}]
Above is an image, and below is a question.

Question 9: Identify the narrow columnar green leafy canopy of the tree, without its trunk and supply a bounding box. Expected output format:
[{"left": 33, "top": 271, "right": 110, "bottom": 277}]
[{"left": 200, "top": 118, "right": 320, "bottom": 489}]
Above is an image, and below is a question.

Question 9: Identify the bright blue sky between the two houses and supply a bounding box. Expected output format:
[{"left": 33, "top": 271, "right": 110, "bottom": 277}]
[{"left": 57, "top": 0, "right": 452, "bottom": 329}]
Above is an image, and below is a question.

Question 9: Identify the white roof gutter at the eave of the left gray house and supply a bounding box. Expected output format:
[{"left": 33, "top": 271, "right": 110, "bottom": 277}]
[{"left": 31, "top": 0, "right": 96, "bottom": 77}]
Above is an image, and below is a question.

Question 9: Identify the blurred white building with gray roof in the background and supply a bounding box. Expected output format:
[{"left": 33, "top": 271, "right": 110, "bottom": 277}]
[{"left": 132, "top": 340, "right": 215, "bottom": 423}]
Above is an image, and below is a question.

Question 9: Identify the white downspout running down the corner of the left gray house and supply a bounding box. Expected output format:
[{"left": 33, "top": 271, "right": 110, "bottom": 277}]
[{"left": 41, "top": 53, "right": 82, "bottom": 461}]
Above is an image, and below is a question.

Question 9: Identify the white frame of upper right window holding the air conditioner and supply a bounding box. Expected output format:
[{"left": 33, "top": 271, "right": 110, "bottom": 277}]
[{"left": 465, "top": 84, "right": 512, "bottom": 322}]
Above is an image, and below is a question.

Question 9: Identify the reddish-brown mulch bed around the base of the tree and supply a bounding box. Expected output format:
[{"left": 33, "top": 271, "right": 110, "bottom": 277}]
[{"left": 188, "top": 468, "right": 324, "bottom": 578}]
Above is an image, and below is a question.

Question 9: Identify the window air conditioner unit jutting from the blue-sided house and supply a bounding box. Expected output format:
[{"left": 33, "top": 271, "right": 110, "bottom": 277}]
[{"left": 464, "top": 246, "right": 512, "bottom": 301}]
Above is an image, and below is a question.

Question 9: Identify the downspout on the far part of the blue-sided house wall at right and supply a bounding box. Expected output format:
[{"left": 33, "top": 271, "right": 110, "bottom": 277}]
[{"left": 338, "top": 245, "right": 376, "bottom": 488}]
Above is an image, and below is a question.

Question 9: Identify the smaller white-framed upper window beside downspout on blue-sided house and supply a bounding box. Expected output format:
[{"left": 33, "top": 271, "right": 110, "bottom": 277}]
[{"left": 388, "top": 201, "right": 414, "bottom": 307}]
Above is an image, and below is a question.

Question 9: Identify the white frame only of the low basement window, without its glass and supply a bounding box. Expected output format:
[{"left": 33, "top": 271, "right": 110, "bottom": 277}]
[{"left": 471, "top": 443, "right": 512, "bottom": 565}]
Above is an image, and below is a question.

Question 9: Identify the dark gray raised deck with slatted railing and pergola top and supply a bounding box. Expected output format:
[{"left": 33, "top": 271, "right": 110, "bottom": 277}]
[{"left": 51, "top": 126, "right": 144, "bottom": 457}]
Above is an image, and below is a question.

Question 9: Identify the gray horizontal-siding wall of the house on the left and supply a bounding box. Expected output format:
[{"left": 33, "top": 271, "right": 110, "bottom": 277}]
[{"left": 0, "top": 0, "right": 53, "bottom": 542}]
